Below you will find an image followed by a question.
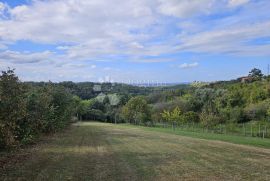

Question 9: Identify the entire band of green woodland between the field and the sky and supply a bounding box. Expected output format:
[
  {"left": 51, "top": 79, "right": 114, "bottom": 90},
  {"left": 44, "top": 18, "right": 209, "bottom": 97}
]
[{"left": 0, "top": 68, "right": 270, "bottom": 149}]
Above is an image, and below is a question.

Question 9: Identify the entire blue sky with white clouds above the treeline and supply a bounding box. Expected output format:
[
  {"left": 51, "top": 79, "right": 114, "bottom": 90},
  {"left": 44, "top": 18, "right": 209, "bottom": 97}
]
[{"left": 0, "top": 0, "right": 270, "bottom": 83}]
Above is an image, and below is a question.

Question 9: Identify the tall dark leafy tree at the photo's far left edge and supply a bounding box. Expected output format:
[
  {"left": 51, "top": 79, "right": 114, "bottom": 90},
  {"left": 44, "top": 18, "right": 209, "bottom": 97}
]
[{"left": 0, "top": 69, "right": 26, "bottom": 147}]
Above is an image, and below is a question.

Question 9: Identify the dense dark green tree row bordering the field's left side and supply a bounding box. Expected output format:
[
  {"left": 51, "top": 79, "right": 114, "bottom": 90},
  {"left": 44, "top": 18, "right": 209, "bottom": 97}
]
[{"left": 0, "top": 70, "right": 76, "bottom": 148}]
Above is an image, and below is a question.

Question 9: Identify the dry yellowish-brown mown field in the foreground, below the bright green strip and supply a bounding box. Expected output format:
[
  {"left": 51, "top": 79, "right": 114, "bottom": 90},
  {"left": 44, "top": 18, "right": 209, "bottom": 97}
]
[{"left": 0, "top": 122, "right": 270, "bottom": 181}]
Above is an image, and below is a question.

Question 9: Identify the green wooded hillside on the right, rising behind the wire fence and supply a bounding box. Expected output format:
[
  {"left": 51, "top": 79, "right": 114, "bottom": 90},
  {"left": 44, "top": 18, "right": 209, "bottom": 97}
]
[{"left": 71, "top": 69, "right": 270, "bottom": 127}]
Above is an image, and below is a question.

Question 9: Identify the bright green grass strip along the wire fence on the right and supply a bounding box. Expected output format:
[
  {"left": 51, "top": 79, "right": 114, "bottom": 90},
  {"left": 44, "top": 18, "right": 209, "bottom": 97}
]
[{"left": 121, "top": 124, "right": 270, "bottom": 148}]
